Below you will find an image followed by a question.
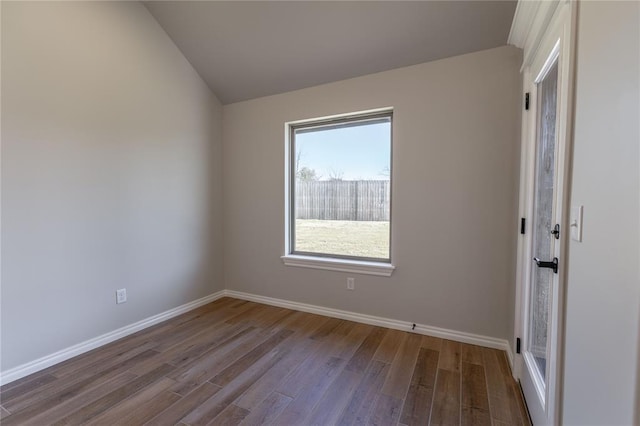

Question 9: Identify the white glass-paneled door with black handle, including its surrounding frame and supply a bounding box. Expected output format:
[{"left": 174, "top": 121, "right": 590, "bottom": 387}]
[{"left": 515, "top": 1, "right": 570, "bottom": 425}]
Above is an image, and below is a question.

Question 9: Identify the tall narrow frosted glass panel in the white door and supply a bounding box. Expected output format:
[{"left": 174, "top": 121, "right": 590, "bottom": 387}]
[{"left": 528, "top": 63, "right": 558, "bottom": 382}]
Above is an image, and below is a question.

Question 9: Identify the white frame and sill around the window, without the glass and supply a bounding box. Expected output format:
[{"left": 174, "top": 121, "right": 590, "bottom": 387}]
[{"left": 281, "top": 108, "right": 395, "bottom": 277}]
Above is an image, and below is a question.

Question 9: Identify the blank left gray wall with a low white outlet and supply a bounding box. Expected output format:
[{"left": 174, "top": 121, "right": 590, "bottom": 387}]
[{"left": 1, "top": 1, "right": 224, "bottom": 370}]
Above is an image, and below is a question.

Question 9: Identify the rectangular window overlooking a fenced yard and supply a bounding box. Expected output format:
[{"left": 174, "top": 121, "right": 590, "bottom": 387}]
[{"left": 283, "top": 110, "right": 393, "bottom": 275}]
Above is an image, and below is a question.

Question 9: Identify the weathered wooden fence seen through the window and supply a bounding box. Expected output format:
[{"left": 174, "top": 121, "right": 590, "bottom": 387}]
[{"left": 295, "top": 180, "right": 391, "bottom": 221}]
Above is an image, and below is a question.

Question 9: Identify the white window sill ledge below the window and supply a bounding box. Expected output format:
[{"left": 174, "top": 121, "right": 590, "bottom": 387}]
[{"left": 281, "top": 254, "right": 396, "bottom": 277}]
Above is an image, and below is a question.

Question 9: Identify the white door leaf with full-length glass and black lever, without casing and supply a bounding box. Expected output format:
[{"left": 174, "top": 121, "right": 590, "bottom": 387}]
[{"left": 521, "top": 53, "right": 564, "bottom": 425}]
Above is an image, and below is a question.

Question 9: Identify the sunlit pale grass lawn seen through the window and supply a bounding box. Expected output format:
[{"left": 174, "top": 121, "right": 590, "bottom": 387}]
[{"left": 295, "top": 219, "right": 389, "bottom": 259}]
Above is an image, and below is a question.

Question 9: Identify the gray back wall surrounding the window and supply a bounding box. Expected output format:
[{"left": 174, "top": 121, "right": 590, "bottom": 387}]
[{"left": 223, "top": 47, "right": 521, "bottom": 339}]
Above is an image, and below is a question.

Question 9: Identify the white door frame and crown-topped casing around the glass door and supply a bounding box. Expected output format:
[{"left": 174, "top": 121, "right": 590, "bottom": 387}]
[{"left": 509, "top": 0, "right": 577, "bottom": 424}]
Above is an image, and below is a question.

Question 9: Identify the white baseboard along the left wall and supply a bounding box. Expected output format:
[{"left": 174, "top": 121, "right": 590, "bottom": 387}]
[{"left": 0, "top": 290, "right": 225, "bottom": 385}]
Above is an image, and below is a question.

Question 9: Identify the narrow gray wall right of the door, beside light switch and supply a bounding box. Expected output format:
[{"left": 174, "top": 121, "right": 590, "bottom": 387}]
[{"left": 564, "top": 1, "right": 640, "bottom": 425}]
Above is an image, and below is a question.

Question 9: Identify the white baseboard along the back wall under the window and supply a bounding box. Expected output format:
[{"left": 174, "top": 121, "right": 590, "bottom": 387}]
[{"left": 224, "top": 290, "right": 513, "bottom": 371}]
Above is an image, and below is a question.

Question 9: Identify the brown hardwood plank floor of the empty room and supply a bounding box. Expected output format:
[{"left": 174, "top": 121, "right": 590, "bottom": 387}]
[{"left": 0, "top": 298, "right": 529, "bottom": 426}]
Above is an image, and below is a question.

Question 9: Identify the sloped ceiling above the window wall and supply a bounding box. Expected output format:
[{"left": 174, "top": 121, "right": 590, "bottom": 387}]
[{"left": 144, "top": 1, "right": 516, "bottom": 104}]
